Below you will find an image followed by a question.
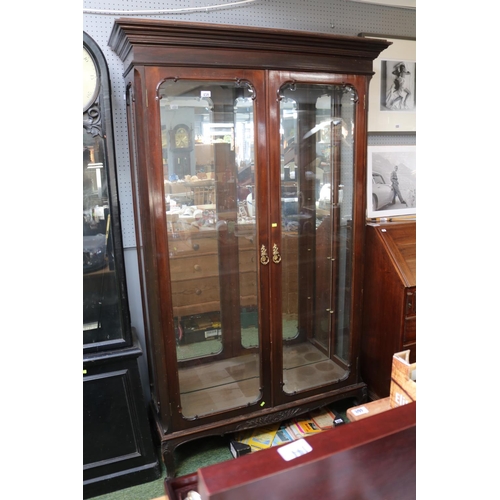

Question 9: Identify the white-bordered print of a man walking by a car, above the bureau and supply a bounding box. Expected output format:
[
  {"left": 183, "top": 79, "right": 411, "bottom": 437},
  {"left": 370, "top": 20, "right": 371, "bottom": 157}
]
[{"left": 366, "top": 146, "right": 417, "bottom": 218}]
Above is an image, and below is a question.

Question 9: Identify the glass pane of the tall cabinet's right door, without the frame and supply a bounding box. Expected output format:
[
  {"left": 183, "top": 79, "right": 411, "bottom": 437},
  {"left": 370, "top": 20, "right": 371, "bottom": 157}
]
[{"left": 275, "top": 81, "right": 356, "bottom": 394}]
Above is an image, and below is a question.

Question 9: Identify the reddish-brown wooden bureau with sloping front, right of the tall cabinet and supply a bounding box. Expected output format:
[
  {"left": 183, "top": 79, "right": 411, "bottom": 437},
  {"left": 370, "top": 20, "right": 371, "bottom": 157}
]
[{"left": 361, "top": 221, "right": 417, "bottom": 399}]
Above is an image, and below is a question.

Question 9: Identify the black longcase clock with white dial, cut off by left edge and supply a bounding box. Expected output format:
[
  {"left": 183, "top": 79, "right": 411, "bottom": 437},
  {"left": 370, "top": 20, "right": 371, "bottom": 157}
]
[{"left": 83, "top": 32, "right": 161, "bottom": 498}]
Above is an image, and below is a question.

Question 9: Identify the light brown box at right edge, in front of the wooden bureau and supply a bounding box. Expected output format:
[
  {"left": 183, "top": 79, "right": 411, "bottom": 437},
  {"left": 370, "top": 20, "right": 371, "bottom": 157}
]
[{"left": 389, "top": 349, "right": 417, "bottom": 408}]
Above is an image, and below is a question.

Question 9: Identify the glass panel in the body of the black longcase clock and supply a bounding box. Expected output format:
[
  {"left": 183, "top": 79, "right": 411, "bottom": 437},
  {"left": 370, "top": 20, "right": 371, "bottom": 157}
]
[{"left": 83, "top": 129, "right": 122, "bottom": 345}]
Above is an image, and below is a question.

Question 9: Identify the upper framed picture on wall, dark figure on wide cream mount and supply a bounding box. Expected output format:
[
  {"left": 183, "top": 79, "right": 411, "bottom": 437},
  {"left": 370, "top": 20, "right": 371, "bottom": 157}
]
[{"left": 359, "top": 33, "right": 417, "bottom": 133}]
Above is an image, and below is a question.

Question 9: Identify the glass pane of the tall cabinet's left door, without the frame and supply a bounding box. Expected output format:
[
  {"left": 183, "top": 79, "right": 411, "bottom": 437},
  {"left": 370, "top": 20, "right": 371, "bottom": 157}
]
[{"left": 158, "top": 78, "right": 261, "bottom": 418}]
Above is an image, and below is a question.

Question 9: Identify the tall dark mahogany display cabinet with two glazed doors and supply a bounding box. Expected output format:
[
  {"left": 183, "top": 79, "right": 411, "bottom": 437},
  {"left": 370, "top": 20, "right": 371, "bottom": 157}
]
[{"left": 109, "top": 18, "right": 389, "bottom": 477}]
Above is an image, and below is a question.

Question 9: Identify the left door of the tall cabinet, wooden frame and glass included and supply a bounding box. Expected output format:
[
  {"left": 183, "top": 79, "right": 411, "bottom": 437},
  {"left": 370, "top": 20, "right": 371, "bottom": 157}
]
[{"left": 128, "top": 64, "right": 270, "bottom": 430}]
